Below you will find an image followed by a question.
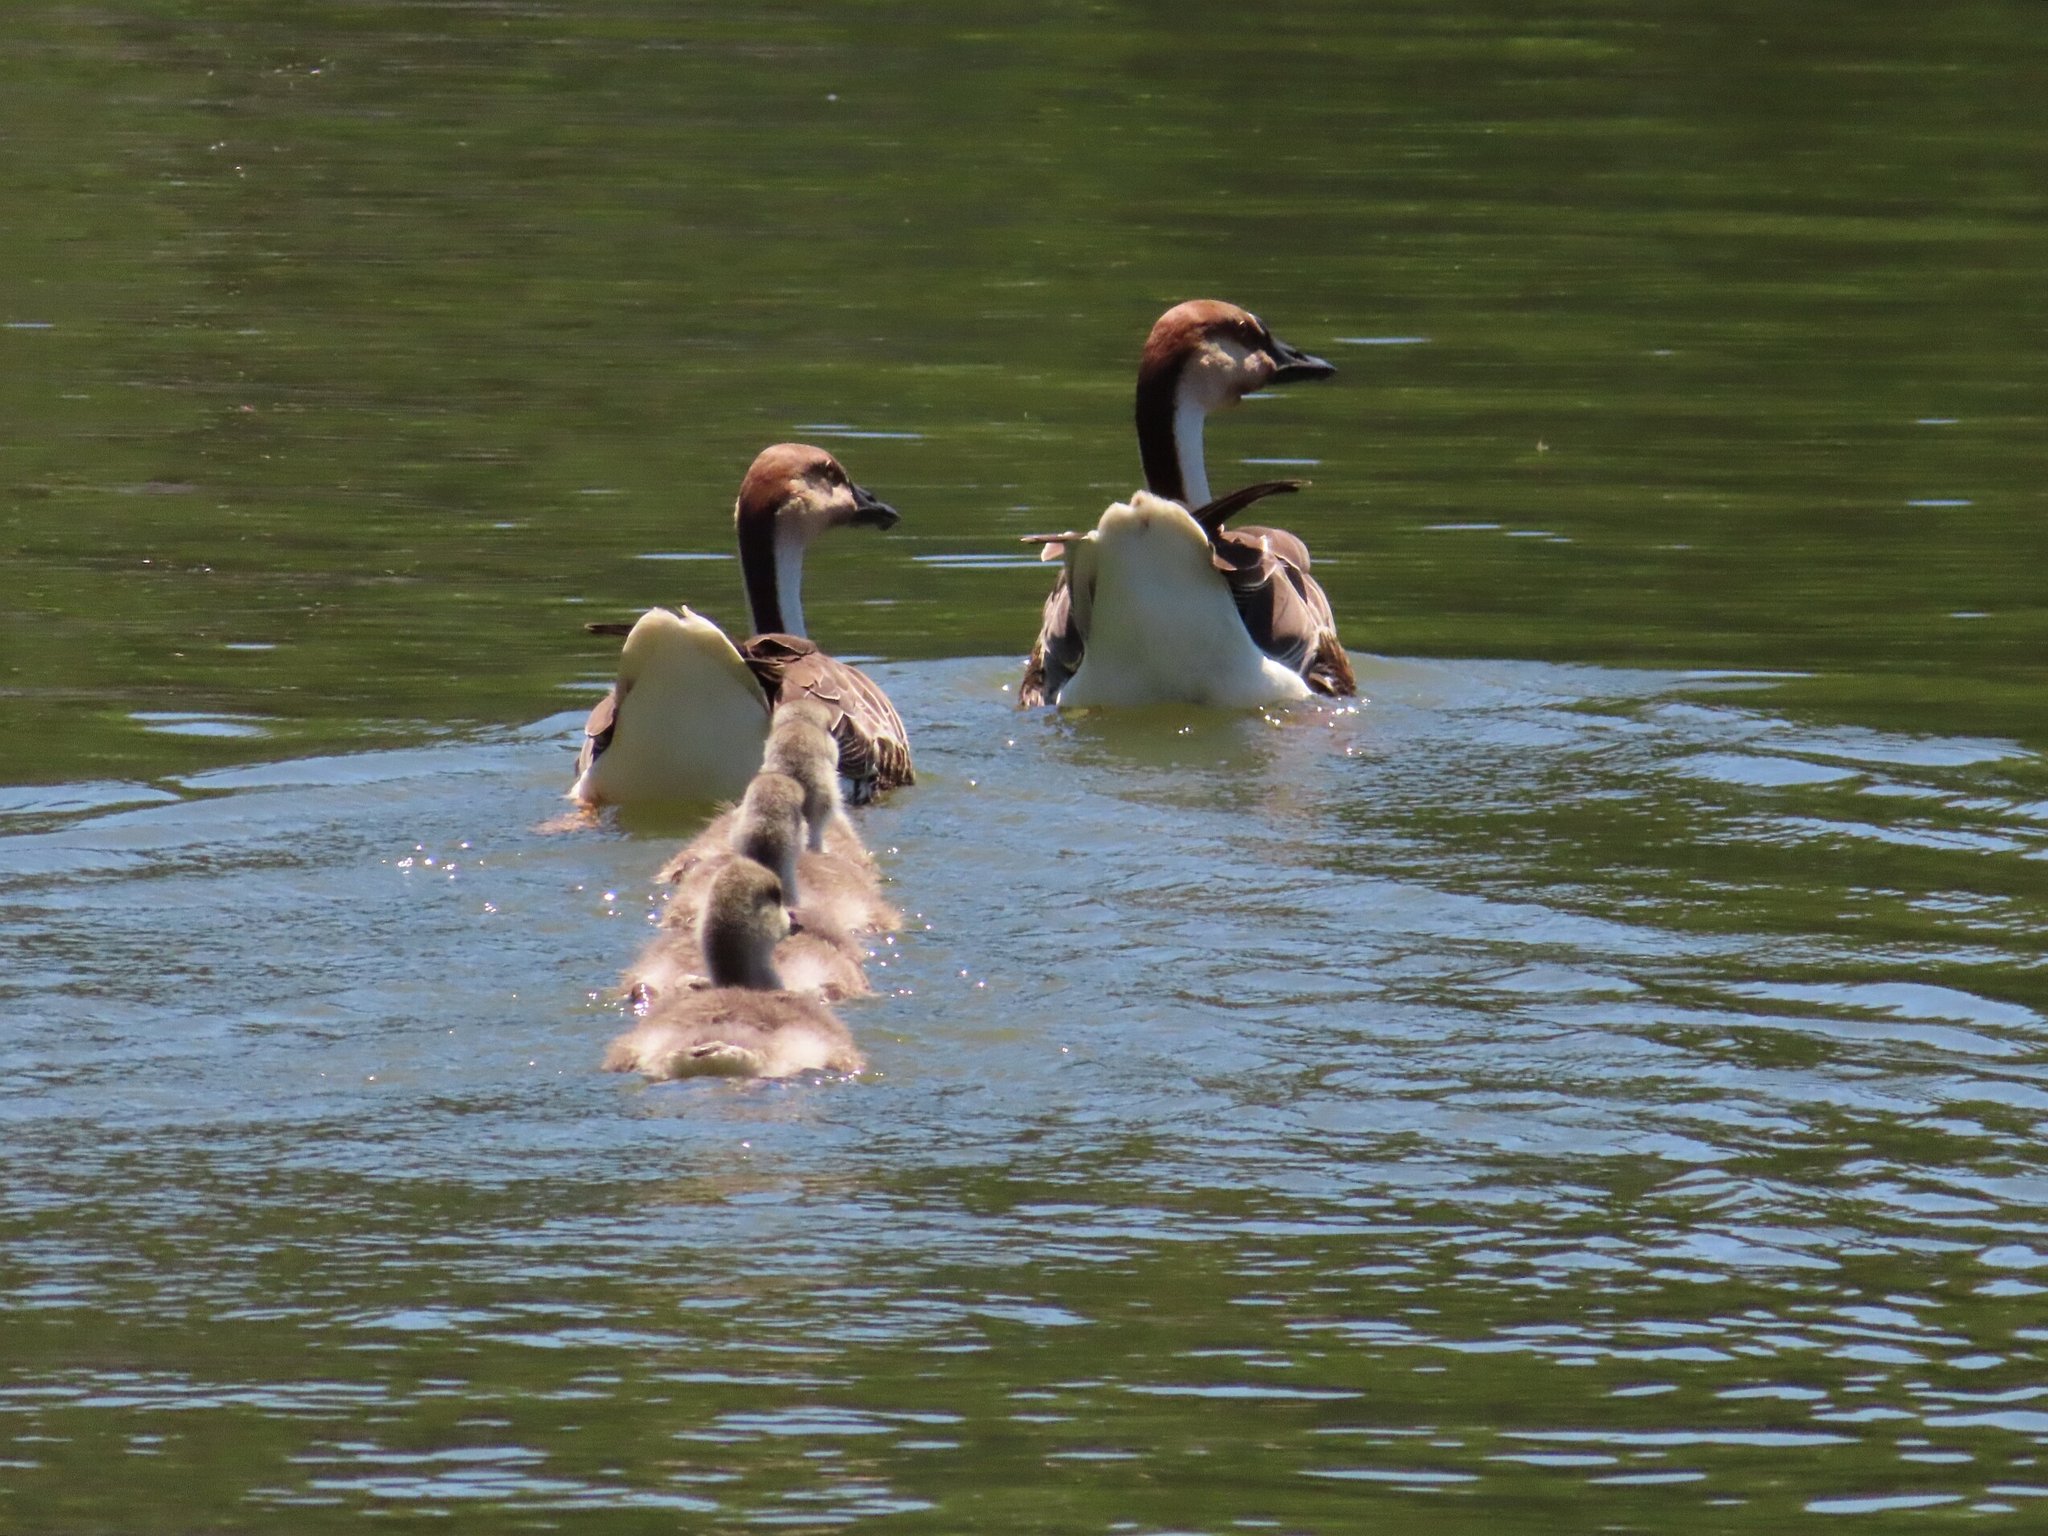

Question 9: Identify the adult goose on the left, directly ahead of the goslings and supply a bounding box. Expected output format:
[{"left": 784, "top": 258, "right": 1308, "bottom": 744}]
[{"left": 569, "top": 442, "right": 913, "bottom": 807}]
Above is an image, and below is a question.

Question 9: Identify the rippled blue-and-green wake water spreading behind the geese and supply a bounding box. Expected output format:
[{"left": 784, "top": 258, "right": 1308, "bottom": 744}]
[{"left": 0, "top": 659, "right": 2048, "bottom": 1530}]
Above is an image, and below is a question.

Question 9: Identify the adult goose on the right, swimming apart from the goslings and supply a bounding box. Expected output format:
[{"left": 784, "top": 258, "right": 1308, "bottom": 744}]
[{"left": 1018, "top": 299, "right": 1358, "bottom": 707}]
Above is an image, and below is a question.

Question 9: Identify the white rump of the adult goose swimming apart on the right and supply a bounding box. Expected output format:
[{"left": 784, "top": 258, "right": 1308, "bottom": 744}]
[{"left": 1059, "top": 492, "right": 1309, "bottom": 709}]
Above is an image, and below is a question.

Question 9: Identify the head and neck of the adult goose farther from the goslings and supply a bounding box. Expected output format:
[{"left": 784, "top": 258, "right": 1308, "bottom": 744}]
[{"left": 1137, "top": 299, "right": 1337, "bottom": 506}]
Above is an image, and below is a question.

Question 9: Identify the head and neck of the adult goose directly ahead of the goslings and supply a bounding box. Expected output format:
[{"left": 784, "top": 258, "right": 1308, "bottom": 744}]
[{"left": 733, "top": 442, "right": 901, "bottom": 635}]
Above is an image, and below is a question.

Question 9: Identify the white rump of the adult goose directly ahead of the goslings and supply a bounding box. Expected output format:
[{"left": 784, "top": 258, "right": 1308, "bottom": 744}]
[{"left": 569, "top": 608, "right": 768, "bottom": 805}]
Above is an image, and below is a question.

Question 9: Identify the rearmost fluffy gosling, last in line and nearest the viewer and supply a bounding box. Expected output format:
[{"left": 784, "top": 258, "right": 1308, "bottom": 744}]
[{"left": 604, "top": 858, "right": 866, "bottom": 1079}]
